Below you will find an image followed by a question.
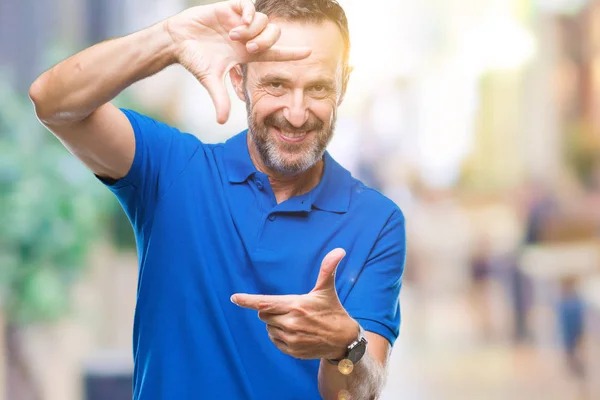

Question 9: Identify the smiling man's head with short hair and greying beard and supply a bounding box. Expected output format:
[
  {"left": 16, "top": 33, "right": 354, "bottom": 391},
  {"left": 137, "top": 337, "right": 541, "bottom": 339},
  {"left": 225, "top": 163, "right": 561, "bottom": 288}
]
[{"left": 231, "top": 0, "right": 350, "bottom": 175}]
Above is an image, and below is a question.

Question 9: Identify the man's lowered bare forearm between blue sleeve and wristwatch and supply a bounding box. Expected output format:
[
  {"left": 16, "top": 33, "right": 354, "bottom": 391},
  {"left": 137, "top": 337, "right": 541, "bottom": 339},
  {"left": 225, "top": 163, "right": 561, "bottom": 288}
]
[{"left": 319, "top": 332, "right": 391, "bottom": 400}]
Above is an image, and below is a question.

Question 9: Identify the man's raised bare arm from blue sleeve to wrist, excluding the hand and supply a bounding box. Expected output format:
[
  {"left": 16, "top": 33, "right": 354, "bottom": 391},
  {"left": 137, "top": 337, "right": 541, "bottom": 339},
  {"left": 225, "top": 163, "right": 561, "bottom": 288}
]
[{"left": 30, "top": 24, "right": 175, "bottom": 179}]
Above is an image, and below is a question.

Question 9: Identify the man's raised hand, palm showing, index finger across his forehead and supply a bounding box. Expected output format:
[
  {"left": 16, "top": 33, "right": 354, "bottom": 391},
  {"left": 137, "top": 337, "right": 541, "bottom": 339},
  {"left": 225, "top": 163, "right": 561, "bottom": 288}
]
[{"left": 165, "top": 0, "right": 310, "bottom": 123}]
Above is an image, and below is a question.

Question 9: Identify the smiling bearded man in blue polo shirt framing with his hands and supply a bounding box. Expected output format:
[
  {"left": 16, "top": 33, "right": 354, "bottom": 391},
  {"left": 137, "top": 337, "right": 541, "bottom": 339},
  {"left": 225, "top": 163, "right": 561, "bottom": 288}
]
[{"left": 30, "top": 0, "right": 405, "bottom": 400}]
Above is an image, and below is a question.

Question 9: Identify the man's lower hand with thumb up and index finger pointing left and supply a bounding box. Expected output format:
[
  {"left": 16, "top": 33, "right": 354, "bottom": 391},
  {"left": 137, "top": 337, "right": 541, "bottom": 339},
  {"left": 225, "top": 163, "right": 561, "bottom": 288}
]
[{"left": 231, "top": 249, "right": 359, "bottom": 359}]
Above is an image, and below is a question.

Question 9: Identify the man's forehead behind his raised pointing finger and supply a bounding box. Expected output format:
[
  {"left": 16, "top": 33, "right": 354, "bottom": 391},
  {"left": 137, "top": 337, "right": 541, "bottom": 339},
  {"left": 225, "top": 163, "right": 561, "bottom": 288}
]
[{"left": 249, "top": 19, "right": 344, "bottom": 77}]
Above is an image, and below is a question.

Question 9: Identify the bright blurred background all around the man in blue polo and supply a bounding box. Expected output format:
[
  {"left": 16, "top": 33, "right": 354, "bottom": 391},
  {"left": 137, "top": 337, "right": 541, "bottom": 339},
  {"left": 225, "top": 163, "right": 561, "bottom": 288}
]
[{"left": 0, "top": 0, "right": 600, "bottom": 400}]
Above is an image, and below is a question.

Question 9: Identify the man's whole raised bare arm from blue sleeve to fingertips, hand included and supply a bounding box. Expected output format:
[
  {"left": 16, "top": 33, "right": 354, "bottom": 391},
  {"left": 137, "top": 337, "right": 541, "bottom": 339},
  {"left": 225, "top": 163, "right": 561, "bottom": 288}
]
[{"left": 30, "top": 0, "right": 310, "bottom": 179}]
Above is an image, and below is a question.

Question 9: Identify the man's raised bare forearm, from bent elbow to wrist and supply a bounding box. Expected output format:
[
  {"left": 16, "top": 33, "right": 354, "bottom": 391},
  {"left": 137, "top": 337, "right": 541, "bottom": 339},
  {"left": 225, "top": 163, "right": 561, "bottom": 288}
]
[{"left": 30, "top": 19, "right": 175, "bottom": 124}]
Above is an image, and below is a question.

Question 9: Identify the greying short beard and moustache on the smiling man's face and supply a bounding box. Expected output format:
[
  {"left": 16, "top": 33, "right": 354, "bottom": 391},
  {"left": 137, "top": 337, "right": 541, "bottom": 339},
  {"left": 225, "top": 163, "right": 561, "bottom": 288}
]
[{"left": 246, "top": 92, "right": 336, "bottom": 176}]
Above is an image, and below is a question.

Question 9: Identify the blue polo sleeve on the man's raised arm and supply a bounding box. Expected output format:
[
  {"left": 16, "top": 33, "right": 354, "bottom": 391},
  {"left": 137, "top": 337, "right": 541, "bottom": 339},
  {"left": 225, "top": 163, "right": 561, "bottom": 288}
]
[{"left": 99, "top": 109, "right": 202, "bottom": 231}]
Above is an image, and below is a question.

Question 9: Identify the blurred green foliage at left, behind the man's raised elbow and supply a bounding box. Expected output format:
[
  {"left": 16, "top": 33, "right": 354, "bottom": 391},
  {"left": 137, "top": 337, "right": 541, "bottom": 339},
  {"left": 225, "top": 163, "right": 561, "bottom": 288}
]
[{"left": 0, "top": 77, "right": 116, "bottom": 324}]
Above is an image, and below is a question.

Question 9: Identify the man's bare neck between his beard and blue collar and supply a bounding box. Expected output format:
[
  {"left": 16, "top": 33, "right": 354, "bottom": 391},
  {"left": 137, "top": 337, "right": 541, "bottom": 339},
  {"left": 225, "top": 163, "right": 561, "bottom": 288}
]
[{"left": 247, "top": 134, "right": 324, "bottom": 204}]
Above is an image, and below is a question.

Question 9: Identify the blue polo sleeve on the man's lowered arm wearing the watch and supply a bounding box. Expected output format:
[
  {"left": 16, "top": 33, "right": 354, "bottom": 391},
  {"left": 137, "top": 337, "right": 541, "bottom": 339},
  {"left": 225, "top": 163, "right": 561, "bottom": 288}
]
[{"left": 344, "top": 209, "right": 406, "bottom": 345}]
